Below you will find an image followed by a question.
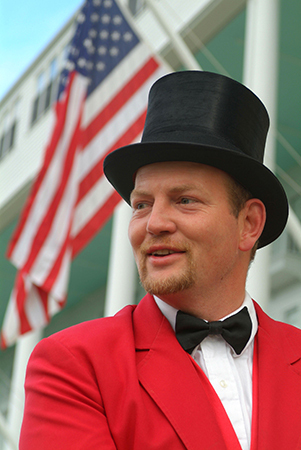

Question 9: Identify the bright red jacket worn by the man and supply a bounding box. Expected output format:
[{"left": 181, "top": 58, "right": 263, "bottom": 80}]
[{"left": 20, "top": 295, "right": 301, "bottom": 450}]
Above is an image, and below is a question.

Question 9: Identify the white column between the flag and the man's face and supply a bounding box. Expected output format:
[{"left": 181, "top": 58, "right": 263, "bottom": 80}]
[{"left": 104, "top": 201, "right": 136, "bottom": 316}]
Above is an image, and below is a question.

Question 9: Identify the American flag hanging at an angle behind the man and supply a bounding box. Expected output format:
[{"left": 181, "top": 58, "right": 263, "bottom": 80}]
[{"left": 1, "top": 0, "right": 168, "bottom": 347}]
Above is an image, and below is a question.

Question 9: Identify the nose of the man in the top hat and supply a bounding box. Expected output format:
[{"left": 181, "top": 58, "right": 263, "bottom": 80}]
[{"left": 146, "top": 202, "right": 176, "bottom": 236}]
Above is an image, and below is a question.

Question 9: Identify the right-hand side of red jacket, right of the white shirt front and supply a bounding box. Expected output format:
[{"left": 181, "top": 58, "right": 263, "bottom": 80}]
[{"left": 251, "top": 304, "right": 301, "bottom": 449}]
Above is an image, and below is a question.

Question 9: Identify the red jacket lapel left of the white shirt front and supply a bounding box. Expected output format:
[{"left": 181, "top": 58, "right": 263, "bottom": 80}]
[{"left": 134, "top": 296, "right": 241, "bottom": 450}]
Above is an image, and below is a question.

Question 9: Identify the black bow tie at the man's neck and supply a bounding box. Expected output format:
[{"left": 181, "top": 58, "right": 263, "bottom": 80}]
[{"left": 176, "top": 306, "right": 252, "bottom": 355}]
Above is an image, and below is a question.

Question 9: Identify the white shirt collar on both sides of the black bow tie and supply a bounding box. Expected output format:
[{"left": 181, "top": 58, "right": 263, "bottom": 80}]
[{"left": 154, "top": 292, "right": 258, "bottom": 353}]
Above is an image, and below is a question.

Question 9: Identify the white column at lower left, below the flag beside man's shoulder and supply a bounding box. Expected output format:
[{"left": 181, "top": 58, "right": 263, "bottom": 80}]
[{"left": 4, "top": 331, "right": 42, "bottom": 450}]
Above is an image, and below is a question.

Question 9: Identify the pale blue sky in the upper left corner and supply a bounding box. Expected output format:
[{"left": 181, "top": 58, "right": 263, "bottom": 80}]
[{"left": 0, "top": 0, "right": 83, "bottom": 100}]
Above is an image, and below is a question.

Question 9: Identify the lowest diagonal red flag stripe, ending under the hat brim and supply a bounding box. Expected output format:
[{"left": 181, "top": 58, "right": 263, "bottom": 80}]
[{"left": 72, "top": 191, "right": 121, "bottom": 259}]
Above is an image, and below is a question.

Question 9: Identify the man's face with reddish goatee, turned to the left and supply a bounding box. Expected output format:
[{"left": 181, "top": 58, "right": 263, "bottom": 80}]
[{"left": 129, "top": 162, "right": 245, "bottom": 300}]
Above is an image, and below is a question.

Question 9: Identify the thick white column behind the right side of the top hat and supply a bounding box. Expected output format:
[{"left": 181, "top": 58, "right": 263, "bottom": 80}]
[{"left": 243, "top": 0, "right": 279, "bottom": 308}]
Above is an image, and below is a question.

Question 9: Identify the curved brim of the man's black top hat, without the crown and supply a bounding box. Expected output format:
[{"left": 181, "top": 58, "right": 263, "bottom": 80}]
[{"left": 104, "top": 141, "right": 288, "bottom": 248}]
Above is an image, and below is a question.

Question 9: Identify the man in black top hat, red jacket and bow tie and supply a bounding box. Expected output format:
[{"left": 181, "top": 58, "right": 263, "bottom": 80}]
[{"left": 20, "top": 71, "right": 301, "bottom": 450}]
